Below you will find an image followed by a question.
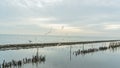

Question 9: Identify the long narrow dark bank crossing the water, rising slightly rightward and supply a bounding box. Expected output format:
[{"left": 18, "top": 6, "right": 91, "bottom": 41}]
[{"left": 0, "top": 40, "right": 120, "bottom": 51}]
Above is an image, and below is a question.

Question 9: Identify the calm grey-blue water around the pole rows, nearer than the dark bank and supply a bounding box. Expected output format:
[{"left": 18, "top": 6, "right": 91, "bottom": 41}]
[{"left": 0, "top": 43, "right": 120, "bottom": 68}]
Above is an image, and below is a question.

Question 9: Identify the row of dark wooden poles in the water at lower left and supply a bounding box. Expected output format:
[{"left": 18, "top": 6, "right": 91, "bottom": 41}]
[{"left": 0, "top": 55, "right": 46, "bottom": 68}]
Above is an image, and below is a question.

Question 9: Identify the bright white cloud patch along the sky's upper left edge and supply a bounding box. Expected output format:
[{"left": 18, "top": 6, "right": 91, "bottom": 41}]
[{"left": 4, "top": 0, "right": 62, "bottom": 8}]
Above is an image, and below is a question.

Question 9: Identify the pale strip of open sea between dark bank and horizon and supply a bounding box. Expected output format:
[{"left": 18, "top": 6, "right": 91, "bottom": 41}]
[{"left": 0, "top": 34, "right": 119, "bottom": 44}]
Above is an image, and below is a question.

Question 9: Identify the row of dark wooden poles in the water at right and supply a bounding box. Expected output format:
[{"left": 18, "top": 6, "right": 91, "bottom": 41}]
[{"left": 73, "top": 42, "right": 120, "bottom": 56}]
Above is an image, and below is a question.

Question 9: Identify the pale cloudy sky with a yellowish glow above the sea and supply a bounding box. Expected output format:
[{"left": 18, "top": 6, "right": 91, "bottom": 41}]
[{"left": 0, "top": 0, "right": 120, "bottom": 36}]
